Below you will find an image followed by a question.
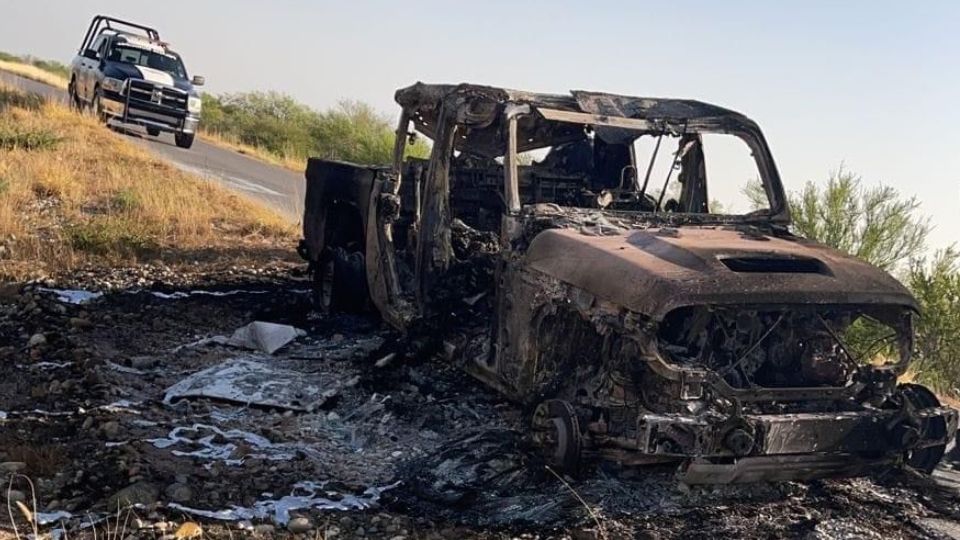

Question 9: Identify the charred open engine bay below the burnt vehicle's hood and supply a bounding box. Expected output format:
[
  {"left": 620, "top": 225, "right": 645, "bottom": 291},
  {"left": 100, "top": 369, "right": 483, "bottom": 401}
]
[{"left": 658, "top": 306, "right": 861, "bottom": 388}]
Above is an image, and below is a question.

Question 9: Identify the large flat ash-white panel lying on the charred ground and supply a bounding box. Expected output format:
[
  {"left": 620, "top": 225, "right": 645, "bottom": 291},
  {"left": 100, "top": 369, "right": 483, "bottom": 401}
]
[{"left": 163, "top": 357, "right": 339, "bottom": 412}]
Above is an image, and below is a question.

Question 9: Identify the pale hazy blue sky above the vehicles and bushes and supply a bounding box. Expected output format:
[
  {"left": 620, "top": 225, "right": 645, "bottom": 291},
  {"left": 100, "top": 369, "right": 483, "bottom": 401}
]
[{"left": 0, "top": 0, "right": 960, "bottom": 247}]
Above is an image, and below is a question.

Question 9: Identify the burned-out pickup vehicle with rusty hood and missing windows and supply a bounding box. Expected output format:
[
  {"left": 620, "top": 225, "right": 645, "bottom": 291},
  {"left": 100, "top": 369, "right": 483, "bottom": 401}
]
[{"left": 301, "top": 83, "right": 957, "bottom": 483}]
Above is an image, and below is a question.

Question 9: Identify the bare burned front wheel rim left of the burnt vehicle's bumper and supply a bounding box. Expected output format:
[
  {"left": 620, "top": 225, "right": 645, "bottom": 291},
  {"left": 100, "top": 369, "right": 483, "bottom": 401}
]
[{"left": 531, "top": 399, "right": 582, "bottom": 474}]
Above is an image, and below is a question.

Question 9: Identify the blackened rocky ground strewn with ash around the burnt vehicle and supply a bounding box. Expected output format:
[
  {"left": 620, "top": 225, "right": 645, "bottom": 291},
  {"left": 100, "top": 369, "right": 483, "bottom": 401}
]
[{"left": 0, "top": 264, "right": 960, "bottom": 540}]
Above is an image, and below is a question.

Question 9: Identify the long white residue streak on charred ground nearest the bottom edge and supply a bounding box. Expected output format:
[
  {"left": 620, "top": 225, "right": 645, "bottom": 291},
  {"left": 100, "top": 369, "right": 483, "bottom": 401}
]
[{"left": 167, "top": 482, "right": 399, "bottom": 525}]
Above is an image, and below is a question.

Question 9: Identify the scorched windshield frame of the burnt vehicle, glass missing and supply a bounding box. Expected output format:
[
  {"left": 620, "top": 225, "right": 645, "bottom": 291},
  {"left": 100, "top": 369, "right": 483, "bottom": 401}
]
[{"left": 503, "top": 104, "right": 790, "bottom": 225}]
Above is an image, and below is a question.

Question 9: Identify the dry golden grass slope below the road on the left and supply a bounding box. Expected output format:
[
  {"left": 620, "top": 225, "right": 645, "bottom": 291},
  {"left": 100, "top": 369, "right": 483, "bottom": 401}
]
[{"left": 0, "top": 86, "right": 295, "bottom": 279}]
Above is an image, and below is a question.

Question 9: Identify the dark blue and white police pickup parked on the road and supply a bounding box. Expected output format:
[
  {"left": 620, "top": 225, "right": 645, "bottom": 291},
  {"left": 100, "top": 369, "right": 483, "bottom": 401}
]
[{"left": 68, "top": 15, "right": 204, "bottom": 148}]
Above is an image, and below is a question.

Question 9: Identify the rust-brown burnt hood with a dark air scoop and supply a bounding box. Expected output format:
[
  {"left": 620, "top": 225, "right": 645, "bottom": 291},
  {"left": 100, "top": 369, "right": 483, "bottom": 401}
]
[{"left": 525, "top": 226, "right": 917, "bottom": 320}]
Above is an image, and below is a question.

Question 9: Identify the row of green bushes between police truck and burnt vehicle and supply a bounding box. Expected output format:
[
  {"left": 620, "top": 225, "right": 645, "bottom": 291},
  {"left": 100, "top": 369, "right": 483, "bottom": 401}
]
[{"left": 201, "top": 92, "right": 429, "bottom": 164}]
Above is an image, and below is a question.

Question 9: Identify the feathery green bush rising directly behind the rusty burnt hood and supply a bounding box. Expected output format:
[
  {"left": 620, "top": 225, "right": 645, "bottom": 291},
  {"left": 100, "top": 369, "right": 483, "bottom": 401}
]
[{"left": 744, "top": 166, "right": 930, "bottom": 271}]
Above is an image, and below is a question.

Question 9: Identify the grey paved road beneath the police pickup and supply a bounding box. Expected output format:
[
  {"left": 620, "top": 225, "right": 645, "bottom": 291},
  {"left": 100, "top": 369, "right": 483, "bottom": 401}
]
[{"left": 0, "top": 71, "right": 304, "bottom": 221}]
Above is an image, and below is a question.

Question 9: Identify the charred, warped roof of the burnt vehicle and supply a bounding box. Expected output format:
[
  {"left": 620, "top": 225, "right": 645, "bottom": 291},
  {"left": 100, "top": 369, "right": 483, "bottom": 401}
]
[{"left": 395, "top": 82, "right": 759, "bottom": 157}]
